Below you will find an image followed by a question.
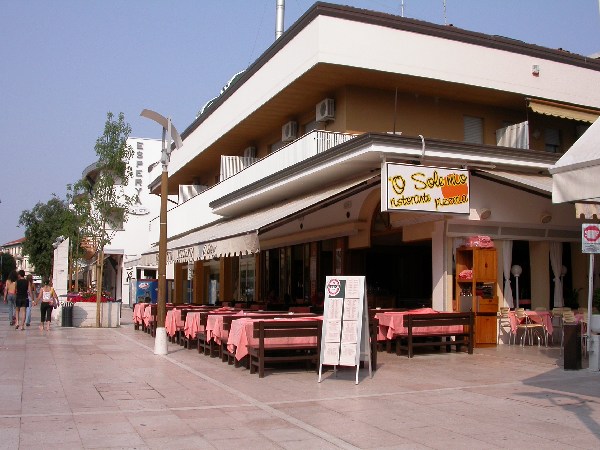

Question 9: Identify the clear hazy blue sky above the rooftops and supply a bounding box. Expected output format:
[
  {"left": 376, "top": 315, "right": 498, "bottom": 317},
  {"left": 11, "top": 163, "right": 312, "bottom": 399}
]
[{"left": 0, "top": 0, "right": 600, "bottom": 245}]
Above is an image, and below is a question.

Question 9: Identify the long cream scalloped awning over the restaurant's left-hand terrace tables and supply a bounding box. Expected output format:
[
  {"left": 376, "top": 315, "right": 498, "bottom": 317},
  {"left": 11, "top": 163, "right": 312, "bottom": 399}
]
[{"left": 142, "top": 174, "right": 374, "bottom": 264}]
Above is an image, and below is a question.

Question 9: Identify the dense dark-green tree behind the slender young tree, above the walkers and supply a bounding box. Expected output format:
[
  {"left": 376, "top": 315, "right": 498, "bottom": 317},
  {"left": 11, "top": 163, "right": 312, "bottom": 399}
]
[{"left": 19, "top": 194, "right": 71, "bottom": 278}]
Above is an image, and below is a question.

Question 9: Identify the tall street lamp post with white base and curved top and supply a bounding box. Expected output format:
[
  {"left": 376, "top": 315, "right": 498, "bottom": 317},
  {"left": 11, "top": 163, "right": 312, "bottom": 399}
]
[{"left": 140, "top": 109, "right": 183, "bottom": 355}]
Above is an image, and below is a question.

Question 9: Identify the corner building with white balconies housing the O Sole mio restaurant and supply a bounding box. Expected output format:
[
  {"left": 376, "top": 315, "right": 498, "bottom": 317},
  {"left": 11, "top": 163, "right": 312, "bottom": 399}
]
[{"left": 142, "top": 3, "right": 600, "bottom": 342}]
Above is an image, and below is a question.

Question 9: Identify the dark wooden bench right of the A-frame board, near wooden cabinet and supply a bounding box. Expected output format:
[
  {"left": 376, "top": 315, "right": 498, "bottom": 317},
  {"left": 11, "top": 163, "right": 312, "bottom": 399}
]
[{"left": 396, "top": 312, "right": 475, "bottom": 358}]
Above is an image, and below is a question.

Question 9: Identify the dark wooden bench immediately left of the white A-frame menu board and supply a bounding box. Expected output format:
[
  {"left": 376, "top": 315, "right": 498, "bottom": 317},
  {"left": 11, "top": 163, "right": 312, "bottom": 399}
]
[{"left": 248, "top": 320, "right": 323, "bottom": 378}]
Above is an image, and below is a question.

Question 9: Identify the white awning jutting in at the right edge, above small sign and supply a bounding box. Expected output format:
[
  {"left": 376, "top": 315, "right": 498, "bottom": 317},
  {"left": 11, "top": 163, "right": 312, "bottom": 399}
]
[{"left": 550, "top": 120, "right": 600, "bottom": 203}]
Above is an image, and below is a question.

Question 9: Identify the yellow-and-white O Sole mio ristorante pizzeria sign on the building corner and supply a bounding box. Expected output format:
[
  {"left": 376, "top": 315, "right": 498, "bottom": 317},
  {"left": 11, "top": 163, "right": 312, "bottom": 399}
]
[{"left": 381, "top": 162, "right": 469, "bottom": 214}]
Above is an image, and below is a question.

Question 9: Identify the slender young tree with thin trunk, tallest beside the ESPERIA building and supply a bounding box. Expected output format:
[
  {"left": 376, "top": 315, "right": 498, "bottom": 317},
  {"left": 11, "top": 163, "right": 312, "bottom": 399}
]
[{"left": 69, "top": 112, "right": 135, "bottom": 327}]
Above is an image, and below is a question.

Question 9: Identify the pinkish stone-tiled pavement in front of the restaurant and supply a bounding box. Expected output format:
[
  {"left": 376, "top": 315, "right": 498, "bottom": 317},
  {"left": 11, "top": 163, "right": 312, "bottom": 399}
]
[{"left": 0, "top": 303, "right": 600, "bottom": 450}]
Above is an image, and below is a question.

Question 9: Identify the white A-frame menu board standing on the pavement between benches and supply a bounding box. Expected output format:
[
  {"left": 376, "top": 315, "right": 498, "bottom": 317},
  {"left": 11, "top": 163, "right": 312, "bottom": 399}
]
[{"left": 319, "top": 275, "right": 373, "bottom": 384}]
